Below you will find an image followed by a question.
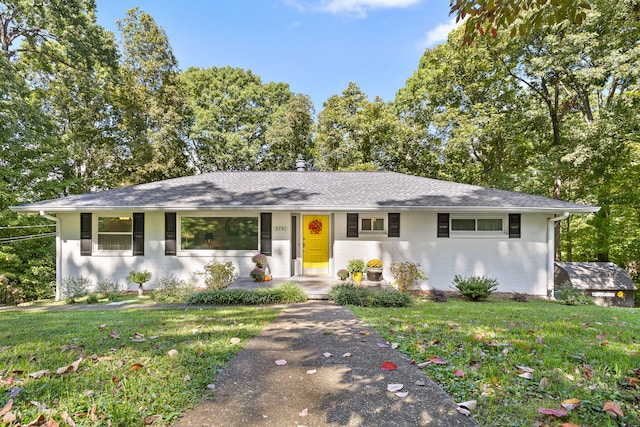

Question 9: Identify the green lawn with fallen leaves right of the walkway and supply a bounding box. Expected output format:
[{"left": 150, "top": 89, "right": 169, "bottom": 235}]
[{"left": 350, "top": 299, "right": 640, "bottom": 426}]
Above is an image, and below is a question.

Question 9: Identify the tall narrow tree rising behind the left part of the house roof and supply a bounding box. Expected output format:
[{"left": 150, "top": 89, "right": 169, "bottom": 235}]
[{"left": 115, "top": 8, "right": 192, "bottom": 184}]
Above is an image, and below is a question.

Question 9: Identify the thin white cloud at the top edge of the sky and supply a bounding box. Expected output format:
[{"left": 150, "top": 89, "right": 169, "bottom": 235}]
[{"left": 284, "top": 0, "right": 422, "bottom": 18}]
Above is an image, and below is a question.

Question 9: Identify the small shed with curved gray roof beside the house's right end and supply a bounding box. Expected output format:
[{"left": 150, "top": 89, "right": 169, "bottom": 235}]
[{"left": 554, "top": 261, "right": 636, "bottom": 307}]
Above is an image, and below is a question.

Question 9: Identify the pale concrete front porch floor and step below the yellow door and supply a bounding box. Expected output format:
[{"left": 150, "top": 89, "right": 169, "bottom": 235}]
[{"left": 229, "top": 276, "right": 392, "bottom": 300}]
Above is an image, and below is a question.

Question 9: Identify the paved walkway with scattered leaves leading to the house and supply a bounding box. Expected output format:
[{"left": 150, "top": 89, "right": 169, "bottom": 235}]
[{"left": 175, "top": 301, "right": 478, "bottom": 427}]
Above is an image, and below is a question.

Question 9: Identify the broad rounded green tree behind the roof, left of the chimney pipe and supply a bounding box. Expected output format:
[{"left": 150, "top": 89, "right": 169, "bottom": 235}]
[{"left": 182, "top": 66, "right": 296, "bottom": 172}]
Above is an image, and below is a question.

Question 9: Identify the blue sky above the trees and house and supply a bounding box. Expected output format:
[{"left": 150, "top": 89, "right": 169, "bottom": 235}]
[{"left": 96, "top": 0, "right": 453, "bottom": 113}]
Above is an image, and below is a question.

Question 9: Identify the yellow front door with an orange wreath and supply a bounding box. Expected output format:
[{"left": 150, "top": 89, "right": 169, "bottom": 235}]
[{"left": 302, "top": 215, "right": 329, "bottom": 276}]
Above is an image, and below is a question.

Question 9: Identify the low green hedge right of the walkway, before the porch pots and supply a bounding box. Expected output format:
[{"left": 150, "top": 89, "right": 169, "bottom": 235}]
[{"left": 329, "top": 283, "right": 413, "bottom": 307}]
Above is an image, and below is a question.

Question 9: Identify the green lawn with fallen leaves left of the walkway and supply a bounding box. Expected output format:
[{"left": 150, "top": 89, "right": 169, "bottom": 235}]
[{"left": 0, "top": 307, "right": 278, "bottom": 426}]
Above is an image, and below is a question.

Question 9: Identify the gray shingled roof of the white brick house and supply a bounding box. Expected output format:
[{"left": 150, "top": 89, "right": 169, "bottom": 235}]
[{"left": 12, "top": 172, "right": 598, "bottom": 213}]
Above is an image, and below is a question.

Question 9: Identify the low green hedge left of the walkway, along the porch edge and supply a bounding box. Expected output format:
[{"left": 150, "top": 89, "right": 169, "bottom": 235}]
[{"left": 185, "top": 282, "right": 307, "bottom": 305}]
